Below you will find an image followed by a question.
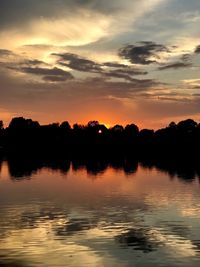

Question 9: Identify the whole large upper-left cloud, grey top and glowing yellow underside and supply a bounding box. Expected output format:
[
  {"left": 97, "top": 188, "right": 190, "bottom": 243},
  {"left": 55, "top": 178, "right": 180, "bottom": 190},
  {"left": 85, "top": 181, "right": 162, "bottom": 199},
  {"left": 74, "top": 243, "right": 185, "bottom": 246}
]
[{"left": 0, "top": 0, "right": 166, "bottom": 52}]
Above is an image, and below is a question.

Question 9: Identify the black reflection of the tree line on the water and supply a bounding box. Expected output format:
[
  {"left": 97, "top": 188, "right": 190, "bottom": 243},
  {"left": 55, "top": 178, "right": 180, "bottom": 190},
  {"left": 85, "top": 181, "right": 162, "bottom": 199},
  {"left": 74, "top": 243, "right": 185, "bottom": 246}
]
[{"left": 0, "top": 158, "right": 200, "bottom": 182}]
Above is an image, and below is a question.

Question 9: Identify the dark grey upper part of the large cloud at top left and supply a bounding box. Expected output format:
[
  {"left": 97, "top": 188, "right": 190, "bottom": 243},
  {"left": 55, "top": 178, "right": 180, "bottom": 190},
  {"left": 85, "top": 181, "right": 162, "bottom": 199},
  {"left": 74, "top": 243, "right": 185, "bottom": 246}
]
[{"left": 0, "top": 0, "right": 138, "bottom": 28}]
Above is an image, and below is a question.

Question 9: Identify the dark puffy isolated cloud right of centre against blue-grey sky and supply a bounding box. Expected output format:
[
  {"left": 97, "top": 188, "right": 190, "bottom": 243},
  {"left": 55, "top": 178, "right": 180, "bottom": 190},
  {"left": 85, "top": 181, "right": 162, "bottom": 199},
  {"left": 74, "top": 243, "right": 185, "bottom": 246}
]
[{"left": 119, "top": 42, "right": 170, "bottom": 65}]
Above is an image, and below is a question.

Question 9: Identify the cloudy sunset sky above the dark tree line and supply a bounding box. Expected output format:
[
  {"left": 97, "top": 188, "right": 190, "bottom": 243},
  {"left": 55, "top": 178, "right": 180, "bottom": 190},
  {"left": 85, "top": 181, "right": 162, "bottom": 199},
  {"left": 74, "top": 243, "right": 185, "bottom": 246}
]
[{"left": 0, "top": 0, "right": 200, "bottom": 129}]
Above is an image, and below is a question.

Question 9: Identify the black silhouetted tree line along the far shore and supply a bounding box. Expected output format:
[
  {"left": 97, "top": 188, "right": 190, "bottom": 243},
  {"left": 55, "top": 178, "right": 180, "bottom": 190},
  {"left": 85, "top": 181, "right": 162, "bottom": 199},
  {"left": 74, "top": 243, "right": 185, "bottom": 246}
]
[{"left": 0, "top": 117, "right": 200, "bottom": 157}]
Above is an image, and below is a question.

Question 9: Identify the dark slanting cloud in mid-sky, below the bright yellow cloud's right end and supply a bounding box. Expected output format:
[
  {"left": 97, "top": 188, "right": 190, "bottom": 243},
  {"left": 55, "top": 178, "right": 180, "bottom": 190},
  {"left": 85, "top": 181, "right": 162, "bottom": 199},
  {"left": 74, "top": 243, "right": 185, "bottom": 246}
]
[{"left": 52, "top": 53, "right": 102, "bottom": 72}]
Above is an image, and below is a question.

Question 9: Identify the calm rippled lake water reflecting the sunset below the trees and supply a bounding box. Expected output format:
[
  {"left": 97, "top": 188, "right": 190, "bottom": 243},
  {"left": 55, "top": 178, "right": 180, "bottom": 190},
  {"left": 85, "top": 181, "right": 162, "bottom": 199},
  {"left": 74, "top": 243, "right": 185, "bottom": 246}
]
[{"left": 0, "top": 162, "right": 200, "bottom": 267}]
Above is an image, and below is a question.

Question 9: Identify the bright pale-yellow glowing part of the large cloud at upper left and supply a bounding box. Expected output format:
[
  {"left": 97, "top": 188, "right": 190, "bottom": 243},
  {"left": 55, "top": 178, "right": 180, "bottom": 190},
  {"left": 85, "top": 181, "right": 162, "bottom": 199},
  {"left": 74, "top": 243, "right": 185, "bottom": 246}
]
[{"left": 0, "top": 10, "right": 111, "bottom": 50}]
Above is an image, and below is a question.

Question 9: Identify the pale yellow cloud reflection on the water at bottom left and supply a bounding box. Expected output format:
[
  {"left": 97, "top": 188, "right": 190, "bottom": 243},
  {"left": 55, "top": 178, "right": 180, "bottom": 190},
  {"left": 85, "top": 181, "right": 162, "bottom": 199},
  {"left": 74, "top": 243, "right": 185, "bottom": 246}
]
[{"left": 0, "top": 226, "right": 106, "bottom": 266}]
